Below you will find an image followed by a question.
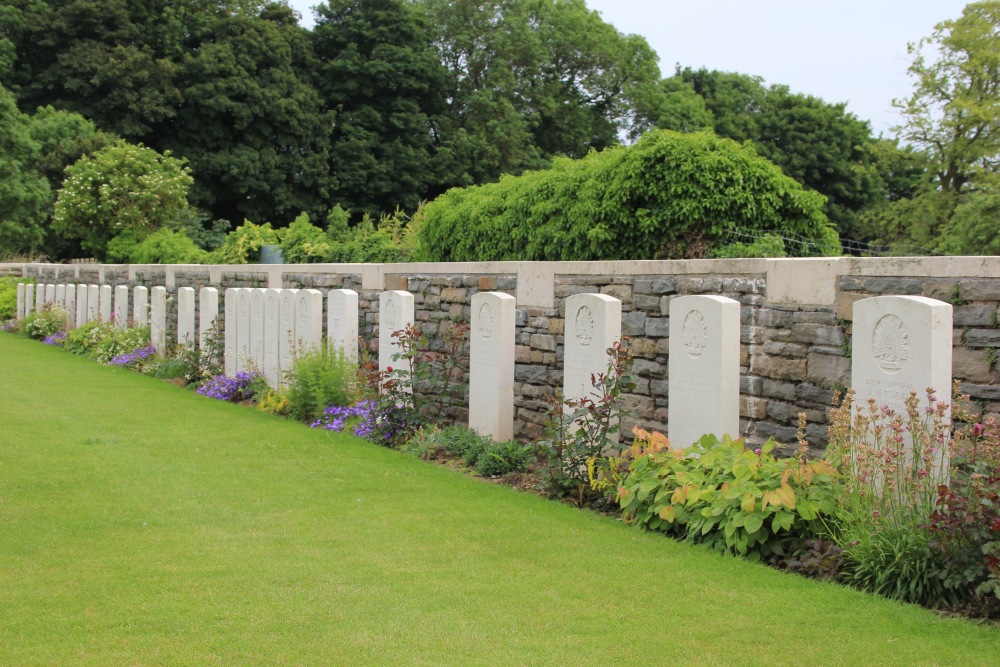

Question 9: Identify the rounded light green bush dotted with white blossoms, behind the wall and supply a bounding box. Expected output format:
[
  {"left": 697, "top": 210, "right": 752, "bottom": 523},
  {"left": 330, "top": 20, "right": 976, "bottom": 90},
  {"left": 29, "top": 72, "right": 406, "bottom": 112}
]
[{"left": 52, "top": 140, "right": 193, "bottom": 259}]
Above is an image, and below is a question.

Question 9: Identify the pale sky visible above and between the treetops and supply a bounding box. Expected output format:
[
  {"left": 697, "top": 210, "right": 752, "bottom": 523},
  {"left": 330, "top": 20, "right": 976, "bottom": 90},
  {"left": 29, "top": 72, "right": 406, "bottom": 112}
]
[{"left": 289, "top": 0, "right": 967, "bottom": 135}]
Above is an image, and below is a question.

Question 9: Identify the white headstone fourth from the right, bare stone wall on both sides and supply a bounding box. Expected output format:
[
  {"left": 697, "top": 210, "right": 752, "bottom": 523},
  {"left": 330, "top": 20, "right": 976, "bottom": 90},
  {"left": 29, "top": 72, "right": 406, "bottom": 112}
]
[{"left": 469, "top": 292, "right": 517, "bottom": 442}]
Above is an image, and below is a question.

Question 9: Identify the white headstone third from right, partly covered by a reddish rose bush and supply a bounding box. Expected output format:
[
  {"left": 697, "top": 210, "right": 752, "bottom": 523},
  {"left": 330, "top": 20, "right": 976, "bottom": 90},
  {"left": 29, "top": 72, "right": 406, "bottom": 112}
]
[{"left": 563, "top": 294, "right": 622, "bottom": 408}]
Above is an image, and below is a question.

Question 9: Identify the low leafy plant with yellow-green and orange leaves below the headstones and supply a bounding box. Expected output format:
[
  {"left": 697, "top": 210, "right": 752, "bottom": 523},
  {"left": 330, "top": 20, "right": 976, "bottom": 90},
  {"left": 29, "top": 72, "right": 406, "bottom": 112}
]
[{"left": 619, "top": 435, "right": 840, "bottom": 560}]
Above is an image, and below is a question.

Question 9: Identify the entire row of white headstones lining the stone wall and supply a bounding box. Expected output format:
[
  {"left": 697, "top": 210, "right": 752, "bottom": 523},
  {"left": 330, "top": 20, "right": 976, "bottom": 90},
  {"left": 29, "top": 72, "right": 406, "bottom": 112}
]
[{"left": 17, "top": 284, "right": 952, "bottom": 462}]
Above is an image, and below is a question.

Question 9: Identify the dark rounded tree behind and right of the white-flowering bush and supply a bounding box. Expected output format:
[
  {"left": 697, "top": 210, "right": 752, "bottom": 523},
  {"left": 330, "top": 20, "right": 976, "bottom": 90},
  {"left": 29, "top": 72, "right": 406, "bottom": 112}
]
[{"left": 162, "top": 4, "right": 331, "bottom": 226}]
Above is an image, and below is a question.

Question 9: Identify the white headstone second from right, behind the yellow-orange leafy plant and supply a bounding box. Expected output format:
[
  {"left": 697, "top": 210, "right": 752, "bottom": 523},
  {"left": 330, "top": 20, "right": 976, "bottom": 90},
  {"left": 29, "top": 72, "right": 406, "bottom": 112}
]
[{"left": 667, "top": 296, "right": 740, "bottom": 449}]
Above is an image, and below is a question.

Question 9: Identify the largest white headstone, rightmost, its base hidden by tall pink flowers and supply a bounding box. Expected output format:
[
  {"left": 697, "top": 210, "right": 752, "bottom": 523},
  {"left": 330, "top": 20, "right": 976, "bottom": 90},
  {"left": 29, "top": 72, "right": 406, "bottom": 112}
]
[{"left": 851, "top": 296, "right": 952, "bottom": 480}]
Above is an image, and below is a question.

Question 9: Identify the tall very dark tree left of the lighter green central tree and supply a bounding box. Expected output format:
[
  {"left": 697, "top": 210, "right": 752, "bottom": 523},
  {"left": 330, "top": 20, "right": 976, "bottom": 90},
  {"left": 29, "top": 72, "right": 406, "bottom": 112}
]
[{"left": 312, "top": 0, "right": 447, "bottom": 217}]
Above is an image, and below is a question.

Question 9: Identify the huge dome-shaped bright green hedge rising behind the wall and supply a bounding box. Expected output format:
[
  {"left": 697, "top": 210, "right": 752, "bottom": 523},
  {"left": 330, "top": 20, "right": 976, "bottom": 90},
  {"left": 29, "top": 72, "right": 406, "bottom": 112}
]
[{"left": 414, "top": 131, "right": 840, "bottom": 261}]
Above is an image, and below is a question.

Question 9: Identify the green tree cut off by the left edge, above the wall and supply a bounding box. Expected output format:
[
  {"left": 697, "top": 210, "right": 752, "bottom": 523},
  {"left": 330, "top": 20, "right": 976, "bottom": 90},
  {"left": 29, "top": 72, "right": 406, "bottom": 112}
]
[{"left": 0, "top": 86, "right": 51, "bottom": 253}]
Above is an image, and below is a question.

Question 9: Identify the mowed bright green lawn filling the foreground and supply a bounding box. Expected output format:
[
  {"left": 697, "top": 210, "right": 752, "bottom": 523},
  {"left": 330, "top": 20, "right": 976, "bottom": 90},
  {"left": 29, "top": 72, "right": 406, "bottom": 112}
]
[{"left": 0, "top": 334, "right": 1000, "bottom": 666}]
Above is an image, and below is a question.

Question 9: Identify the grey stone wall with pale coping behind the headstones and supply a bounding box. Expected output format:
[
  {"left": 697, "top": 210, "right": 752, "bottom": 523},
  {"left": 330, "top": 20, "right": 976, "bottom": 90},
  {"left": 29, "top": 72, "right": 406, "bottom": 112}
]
[{"left": 7, "top": 257, "right": 1000, "bottom": 454}]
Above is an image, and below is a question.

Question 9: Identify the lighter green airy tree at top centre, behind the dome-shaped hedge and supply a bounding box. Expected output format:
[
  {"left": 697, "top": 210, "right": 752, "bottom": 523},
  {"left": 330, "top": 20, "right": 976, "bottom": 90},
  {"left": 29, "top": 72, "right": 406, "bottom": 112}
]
[{"left": 417, "top": 0, "right": 660, "bottom": 183}]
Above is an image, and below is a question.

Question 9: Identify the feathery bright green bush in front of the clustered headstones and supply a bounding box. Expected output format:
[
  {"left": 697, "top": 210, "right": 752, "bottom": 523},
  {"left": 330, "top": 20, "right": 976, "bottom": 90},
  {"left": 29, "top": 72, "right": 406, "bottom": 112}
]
[{"left": 284, "top": 341, "right": 356, "bottom": 423}]
